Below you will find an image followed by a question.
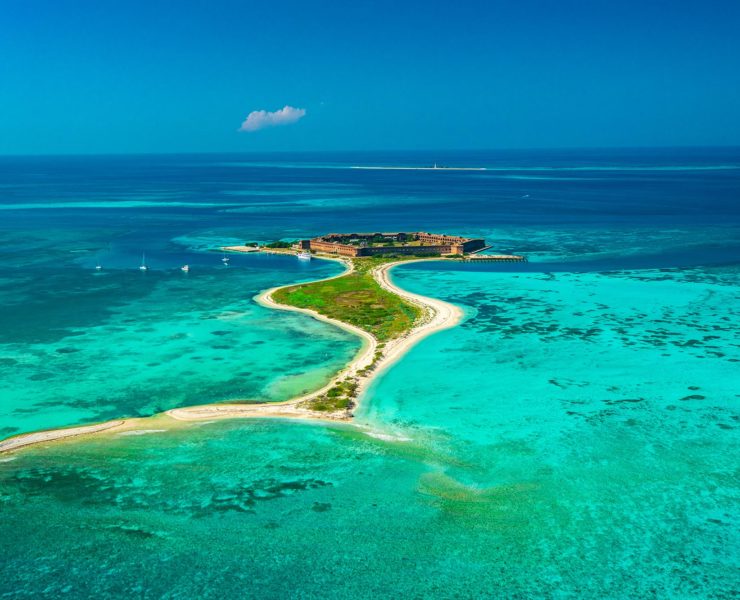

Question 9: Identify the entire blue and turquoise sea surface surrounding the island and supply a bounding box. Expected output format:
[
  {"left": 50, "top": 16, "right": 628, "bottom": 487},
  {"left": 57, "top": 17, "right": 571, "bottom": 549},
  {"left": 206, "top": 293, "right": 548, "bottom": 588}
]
[{"left": 0, "top": 149, "right": 740, "bottom": 598}]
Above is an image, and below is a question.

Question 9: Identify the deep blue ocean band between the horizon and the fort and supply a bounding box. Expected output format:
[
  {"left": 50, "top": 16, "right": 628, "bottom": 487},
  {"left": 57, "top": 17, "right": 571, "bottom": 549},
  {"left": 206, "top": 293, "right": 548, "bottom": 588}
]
[{"left": 0, "top": 149, "right": 740, "bottom": 268}]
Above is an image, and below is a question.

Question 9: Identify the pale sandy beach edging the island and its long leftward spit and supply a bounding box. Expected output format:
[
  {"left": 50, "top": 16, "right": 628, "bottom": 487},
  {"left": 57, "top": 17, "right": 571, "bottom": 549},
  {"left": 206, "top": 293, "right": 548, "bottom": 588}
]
[{"left": 0, "top": 253, "right": 463, "bottom": 454}]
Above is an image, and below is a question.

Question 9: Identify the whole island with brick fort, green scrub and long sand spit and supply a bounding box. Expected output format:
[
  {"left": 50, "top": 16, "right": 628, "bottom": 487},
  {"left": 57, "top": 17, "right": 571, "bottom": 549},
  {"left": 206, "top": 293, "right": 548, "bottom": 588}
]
[{"left": 0, "top": 232, "right": 526, "bottom": 452}]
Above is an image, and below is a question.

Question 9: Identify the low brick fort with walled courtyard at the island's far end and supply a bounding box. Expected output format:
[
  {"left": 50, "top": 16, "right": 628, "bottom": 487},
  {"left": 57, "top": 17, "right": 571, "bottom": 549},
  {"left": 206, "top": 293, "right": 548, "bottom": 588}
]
[{"left": 301, "top": 231, "right": 486, "bottom": 257}]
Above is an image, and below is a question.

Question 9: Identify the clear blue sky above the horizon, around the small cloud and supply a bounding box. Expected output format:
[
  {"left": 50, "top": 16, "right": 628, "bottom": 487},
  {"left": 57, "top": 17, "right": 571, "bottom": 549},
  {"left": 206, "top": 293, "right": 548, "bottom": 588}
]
[{"left": 0, "top": 0, "right": 740, "bottom": 154}]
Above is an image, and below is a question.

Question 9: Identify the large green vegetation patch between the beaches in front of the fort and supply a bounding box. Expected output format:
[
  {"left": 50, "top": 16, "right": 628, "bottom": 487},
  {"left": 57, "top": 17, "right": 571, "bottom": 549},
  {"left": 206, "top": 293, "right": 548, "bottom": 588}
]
[{"left": 273, "top": 257, "right": 421, "bottom": 342}]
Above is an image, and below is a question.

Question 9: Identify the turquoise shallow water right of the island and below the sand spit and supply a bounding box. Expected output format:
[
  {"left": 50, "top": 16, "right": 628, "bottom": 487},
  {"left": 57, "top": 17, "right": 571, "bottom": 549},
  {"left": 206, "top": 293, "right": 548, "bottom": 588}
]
[{"left": 0, "top": 264, "right": 740, "bottom": 598}]
